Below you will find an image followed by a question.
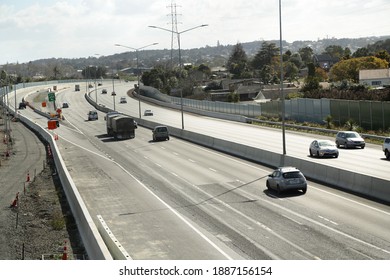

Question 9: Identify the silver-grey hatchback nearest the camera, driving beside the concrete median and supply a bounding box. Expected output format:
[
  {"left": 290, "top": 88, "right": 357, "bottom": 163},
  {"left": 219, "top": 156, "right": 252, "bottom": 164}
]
[{"left": 266, "top": 166, "right": 307, "bottom": 194}]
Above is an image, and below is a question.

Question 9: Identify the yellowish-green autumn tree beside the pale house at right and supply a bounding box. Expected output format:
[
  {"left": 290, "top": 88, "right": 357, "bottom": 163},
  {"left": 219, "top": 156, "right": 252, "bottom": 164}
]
[{"left": 330, "top": 56, "right": 388, "bottom": 83}]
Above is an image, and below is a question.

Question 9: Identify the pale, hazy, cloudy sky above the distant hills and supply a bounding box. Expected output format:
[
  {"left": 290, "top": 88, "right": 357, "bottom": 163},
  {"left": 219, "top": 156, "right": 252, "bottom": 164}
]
[{"left": 0, "top": 0, "right": 390, "bottom": 65}]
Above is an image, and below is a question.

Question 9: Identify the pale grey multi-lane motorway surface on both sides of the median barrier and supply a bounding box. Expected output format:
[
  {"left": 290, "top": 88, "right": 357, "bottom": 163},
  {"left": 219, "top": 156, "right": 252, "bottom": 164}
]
[{"left": 8, "top": 83, "right": 390, "bottom": 259}]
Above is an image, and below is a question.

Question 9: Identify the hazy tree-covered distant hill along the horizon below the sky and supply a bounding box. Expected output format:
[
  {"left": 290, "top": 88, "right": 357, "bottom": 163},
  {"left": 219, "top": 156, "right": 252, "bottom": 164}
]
[{"left": 0, "top": 35, "right": 390, "bottom": 77}]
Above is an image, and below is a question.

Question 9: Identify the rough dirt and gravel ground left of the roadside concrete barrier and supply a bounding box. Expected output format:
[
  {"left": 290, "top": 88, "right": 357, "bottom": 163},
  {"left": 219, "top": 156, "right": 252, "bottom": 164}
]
[{"left": 0, "top": 119, "right": 87, "bottom": 260}]
